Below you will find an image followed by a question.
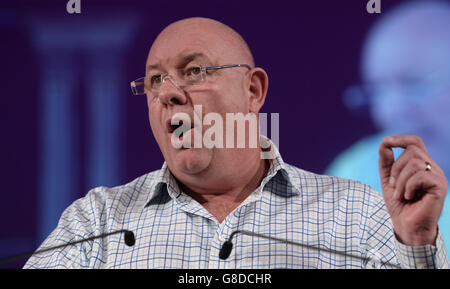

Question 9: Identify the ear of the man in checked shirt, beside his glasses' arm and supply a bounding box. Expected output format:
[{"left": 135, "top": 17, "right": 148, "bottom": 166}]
[{"left": 248, "top": 67, "right": 269, "bottom": 113}]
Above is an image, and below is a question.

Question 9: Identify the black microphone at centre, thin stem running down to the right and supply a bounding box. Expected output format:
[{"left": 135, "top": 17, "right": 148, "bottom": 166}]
[{"left": 219, "top": 230, "right": 401, "bottom": 269}]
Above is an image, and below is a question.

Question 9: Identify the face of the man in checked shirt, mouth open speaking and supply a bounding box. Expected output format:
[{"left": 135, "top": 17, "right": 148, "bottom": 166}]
[{"left": 146, "top": 22, "right": 249, "bottom": 177}]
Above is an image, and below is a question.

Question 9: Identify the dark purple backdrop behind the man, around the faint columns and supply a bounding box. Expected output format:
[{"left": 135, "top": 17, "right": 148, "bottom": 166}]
[{"left": 0, "top": 0, "right": 402, "bottom": 268}]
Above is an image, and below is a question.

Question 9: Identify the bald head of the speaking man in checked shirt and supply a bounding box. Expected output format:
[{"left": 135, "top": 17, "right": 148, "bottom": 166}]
[{"left": 146, "top": 18, "right": 268, "bottom": 189}]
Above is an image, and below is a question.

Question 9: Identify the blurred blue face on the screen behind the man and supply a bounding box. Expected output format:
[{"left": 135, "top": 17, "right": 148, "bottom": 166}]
[{"left": 363, "top": 4, "right": 450, "bottom": 138}]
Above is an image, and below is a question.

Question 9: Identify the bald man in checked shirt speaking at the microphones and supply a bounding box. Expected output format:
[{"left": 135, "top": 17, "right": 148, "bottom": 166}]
[{"left": 25, "top": 18, "right": 449, "bottom": 269}]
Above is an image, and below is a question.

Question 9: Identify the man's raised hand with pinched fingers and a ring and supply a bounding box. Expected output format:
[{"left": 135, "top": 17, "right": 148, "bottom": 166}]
[{"left": 378, "top": 135, "right": 448, "bottom": 246}]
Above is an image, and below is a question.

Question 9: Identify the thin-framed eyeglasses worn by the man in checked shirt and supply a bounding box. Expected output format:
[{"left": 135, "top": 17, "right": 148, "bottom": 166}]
[{"left": 130, "top": 64, "right": 251, "bottom": 95}]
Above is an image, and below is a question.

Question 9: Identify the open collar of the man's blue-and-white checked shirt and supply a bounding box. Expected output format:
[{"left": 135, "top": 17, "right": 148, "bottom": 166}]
[{"left": 144, "top": 135, "right": 300, "bottom": 208}]
